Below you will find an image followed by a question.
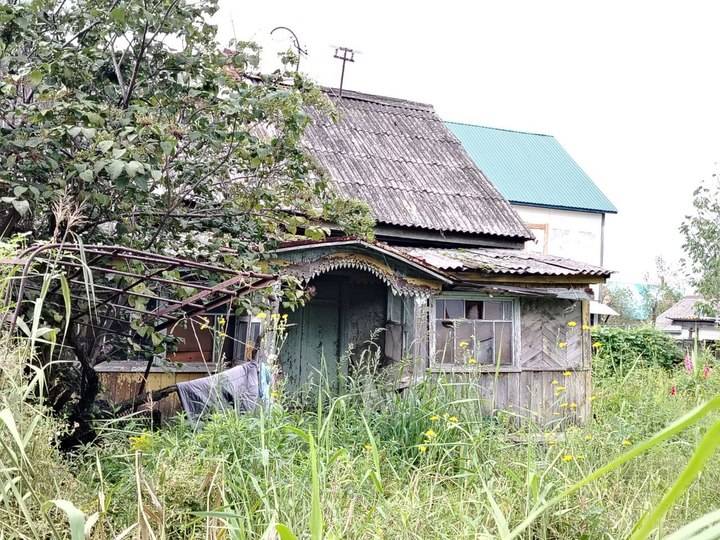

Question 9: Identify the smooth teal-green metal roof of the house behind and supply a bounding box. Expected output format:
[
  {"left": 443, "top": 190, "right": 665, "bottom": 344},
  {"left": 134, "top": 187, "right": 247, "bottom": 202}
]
[{"left": 445, "top": 122, "right": 617, "bottom": 213}]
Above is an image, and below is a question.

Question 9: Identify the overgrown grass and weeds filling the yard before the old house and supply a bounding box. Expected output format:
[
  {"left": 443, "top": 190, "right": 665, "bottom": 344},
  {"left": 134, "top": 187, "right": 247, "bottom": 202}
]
[{"left": 0, "top": 330, "right": 720, "bottom": 539}]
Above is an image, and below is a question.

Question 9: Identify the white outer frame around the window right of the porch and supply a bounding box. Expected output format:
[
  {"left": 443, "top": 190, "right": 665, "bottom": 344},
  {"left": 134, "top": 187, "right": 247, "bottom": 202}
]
[{"left": 428, "top": 292, "right": 521, "bottom": 372}]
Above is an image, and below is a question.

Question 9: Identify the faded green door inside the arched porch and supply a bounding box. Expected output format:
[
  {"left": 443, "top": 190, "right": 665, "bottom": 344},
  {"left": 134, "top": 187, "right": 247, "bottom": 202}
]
[{"left": 280, "top": 280, "right": 340, "bottom": 392}]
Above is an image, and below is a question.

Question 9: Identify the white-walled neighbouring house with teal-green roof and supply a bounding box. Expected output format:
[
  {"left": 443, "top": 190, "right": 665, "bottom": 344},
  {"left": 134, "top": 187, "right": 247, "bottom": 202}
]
[{"left": 446, "top": 122, "right": 617, "bottom": 266}]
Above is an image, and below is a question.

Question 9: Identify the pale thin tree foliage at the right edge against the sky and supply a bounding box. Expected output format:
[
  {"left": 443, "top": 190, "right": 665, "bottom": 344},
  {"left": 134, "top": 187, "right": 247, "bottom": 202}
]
[{"left": 680, "top": 174, "right": 720, "bottom": 316}]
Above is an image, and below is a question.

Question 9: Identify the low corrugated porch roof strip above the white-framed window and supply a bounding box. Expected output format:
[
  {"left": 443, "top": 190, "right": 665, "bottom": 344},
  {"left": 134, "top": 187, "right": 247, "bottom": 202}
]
[{"left": 393, "top": 246, "right": 611, "bottom": 277}]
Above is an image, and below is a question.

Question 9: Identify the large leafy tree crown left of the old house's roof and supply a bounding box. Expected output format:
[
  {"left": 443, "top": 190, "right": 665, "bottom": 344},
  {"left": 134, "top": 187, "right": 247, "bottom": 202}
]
[{"left": 0, "top": 0, "right": 368, "bottom": 255}]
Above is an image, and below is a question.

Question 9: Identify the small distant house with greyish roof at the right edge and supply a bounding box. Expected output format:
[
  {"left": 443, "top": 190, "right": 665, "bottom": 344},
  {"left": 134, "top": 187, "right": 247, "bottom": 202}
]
[{"left": 655, "top": 296, "right": 720, "bottom": 343}]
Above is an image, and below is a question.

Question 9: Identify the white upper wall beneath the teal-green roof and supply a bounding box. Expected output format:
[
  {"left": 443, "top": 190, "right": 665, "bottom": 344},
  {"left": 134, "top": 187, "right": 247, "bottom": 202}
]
[{"left": 512, "top": 204, "right": 603, "bottom": 266}]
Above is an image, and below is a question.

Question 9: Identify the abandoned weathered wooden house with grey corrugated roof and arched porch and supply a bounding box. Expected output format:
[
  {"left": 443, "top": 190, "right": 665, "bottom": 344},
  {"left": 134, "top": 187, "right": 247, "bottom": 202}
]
[{"left": 99, "top": 90, "right": 609, "bottom": 421}]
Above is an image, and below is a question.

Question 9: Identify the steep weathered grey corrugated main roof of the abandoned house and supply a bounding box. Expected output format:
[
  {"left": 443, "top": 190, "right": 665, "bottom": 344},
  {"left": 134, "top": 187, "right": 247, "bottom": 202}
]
[{"left": 304, "top": 90, "right": 532, "bottom": 240}]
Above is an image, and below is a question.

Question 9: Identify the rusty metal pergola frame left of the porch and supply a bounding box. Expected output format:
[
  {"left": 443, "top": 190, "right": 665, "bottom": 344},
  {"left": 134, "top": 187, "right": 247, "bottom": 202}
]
[{"left": 0, "top": 243, "right": 277, "bottom": 395}]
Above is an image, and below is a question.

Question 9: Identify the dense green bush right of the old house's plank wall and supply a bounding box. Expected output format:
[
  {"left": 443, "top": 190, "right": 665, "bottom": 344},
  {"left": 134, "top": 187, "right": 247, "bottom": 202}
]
[{"left": 592, "top": 326, "right": 682, "bottom": 372}]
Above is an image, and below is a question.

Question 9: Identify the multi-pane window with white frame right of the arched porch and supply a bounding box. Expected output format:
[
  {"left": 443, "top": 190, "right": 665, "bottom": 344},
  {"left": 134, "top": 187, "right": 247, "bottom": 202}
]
[{"left": 433, "top": 298, "right": 515, "bottom": 366}]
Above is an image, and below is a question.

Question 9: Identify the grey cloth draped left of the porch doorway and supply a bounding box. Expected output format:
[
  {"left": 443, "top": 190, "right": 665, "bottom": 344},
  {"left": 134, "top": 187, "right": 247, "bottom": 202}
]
[{"left": 177, "top": 362, "right": 260, "bottom": 424}]
